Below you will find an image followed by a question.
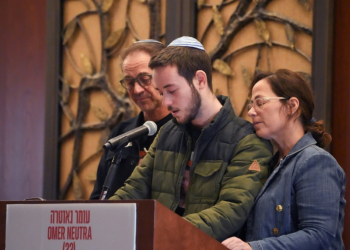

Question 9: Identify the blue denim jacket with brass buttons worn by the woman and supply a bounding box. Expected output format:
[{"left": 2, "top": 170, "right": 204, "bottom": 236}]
[{"left": 246, "top": 133, "right": 346, "bottom": 250}]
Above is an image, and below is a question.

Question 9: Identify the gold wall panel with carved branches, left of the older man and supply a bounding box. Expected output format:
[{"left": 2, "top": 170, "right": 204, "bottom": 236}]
[{"left": 59, "top": 0, "right": 166, "bottom": 200}]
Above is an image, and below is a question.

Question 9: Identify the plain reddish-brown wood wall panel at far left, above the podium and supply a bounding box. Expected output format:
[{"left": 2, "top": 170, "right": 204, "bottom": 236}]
[{"left": 0, "top": 0, "right": 46, "bottom": 200}]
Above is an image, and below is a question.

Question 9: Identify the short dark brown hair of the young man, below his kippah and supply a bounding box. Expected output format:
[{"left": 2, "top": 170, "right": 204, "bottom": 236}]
[{"left": 148, "top": 46, "right": 213, "bottom": 91}]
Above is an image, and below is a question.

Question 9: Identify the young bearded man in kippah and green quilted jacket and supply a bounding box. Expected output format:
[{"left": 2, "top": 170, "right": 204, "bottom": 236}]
[{"left": 111, "top": 37, "right": 272, "bottom": 241}]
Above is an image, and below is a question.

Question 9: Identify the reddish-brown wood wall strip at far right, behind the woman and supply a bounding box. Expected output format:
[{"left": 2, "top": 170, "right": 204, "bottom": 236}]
[{"left": 332, "top": 0, "right": 350, "bottom": 248}]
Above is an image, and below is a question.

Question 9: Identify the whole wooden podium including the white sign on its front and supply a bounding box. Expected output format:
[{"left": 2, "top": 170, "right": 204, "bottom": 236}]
[{"left": 0, "top": 200, "right": 227, "bottom": 250}]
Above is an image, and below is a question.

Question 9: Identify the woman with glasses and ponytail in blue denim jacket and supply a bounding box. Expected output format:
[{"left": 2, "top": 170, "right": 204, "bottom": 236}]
[{"left": 223, "top": 69, "right": 345, "bottom": 250}]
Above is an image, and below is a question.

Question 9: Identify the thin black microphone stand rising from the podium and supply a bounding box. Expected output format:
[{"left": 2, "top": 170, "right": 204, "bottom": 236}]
[{"left": 100, "top": 137, "right": 129, "bottom": 200}]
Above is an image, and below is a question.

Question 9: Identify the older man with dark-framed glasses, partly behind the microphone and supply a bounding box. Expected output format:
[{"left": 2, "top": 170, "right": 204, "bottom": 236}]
[{"left": 90, "top": 39, "right": 172, "bottom": 199}]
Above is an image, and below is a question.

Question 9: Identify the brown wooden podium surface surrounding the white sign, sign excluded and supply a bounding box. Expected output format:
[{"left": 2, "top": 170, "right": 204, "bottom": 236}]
[{"left": 0, "top": 200, "right": 227, "bottom": 250}]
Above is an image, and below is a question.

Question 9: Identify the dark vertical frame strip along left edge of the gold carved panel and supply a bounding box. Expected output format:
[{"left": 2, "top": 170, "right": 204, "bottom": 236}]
[{"left": 43, "top": 0, "right": 62, "bottom": 200}]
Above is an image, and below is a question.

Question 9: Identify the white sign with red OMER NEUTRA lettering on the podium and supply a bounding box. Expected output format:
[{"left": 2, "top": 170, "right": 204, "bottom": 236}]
[{"left": 5, "top": 203, "right": 136, "bottom": 250}]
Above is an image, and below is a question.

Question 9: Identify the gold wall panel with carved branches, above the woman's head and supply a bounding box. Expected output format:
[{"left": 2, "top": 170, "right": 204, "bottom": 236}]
[{"left": 196, "top": 0, "right": 314, "bottom": 121}]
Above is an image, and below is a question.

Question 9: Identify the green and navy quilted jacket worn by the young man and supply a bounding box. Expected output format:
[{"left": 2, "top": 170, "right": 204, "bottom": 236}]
[{"left": 111, "top": 96, "right": 272, "bottom": 241}]
